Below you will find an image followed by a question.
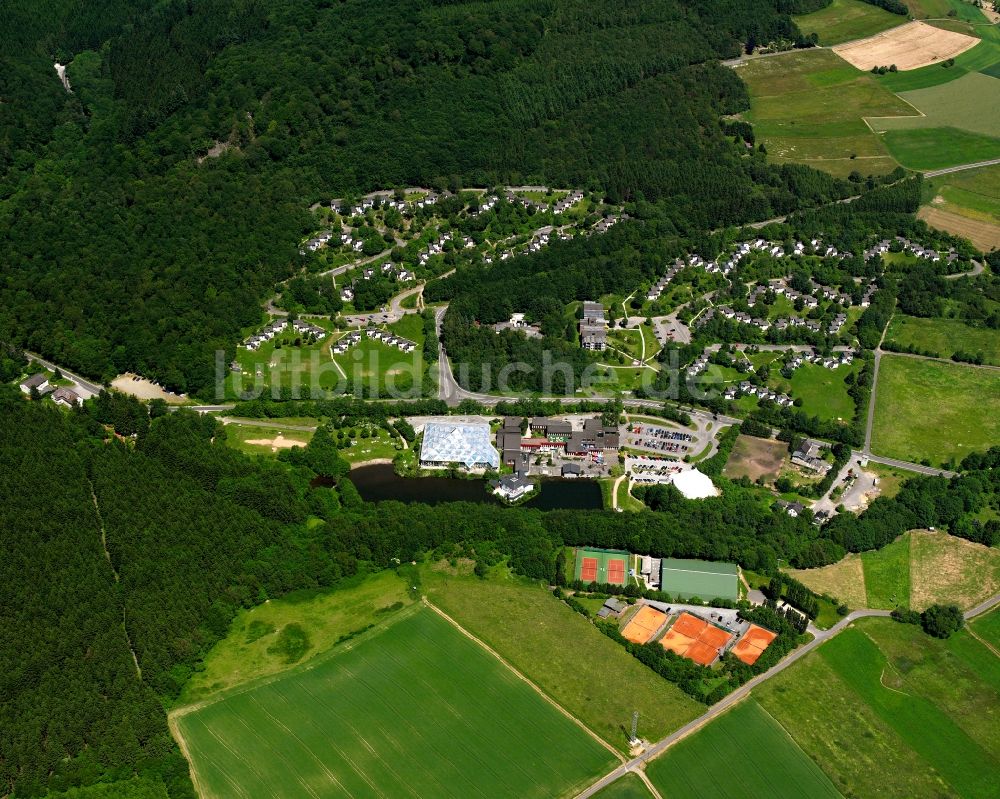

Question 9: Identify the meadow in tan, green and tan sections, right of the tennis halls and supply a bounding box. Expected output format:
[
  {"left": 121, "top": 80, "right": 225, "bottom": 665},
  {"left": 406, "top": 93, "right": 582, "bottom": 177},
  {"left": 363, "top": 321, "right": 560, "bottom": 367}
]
[{"left": 791, "top": 530, "right": 1000, "bottom": 610}]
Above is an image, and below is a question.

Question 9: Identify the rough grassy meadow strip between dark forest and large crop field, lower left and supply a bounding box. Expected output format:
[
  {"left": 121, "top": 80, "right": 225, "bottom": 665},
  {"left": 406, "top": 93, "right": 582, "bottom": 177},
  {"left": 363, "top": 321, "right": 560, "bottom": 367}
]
[{"left": 180, "top": 571, "right": 411, "bottom": 704}]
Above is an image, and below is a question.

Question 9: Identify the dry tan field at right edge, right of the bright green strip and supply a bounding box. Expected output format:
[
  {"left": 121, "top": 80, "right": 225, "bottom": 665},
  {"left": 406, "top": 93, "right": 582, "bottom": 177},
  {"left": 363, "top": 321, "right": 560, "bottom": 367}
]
[{"left": 910, "top": 530, "right": 1000, "bottom": 610}]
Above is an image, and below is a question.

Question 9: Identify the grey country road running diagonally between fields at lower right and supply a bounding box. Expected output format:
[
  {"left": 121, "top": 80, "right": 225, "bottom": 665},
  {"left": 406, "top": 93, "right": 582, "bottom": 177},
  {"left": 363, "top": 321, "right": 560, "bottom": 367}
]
[{"left": 576, "top": 594, "right": 1000, "bottom": 799}]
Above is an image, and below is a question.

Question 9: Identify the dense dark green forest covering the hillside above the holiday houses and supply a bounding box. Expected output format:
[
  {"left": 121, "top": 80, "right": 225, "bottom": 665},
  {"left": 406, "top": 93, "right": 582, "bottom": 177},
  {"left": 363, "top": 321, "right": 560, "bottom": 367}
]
[{"left": 0, "top": 0, "right": 860, "bottom": 392}]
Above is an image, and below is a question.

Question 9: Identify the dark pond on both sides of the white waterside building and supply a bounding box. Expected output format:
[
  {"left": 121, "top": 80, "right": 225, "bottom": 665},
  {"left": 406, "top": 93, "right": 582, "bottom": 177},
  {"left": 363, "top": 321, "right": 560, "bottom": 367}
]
[{"left": 350, "top": 464, "right": 603, "bottom": 510}]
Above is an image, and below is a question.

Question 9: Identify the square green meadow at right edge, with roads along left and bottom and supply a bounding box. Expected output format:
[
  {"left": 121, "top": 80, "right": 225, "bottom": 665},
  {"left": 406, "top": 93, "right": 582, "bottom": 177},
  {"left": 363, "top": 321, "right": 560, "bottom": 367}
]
[{"left": 872, "top": 355, "right": 1000, "bottom": 465}]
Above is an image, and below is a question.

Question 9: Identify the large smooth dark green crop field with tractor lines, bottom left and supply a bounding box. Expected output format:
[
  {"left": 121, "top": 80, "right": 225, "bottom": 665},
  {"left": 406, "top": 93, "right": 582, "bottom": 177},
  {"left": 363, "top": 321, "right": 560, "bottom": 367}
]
[{"left": 174, "top": 606, "right": 615, "bottom": 799}]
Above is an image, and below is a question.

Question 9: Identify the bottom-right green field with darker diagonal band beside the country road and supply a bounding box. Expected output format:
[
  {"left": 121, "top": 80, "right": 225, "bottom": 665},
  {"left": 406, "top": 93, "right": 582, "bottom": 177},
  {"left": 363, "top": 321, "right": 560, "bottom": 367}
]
[{"left": 754, "top": 619, "right": 1000, "bottom": 799}]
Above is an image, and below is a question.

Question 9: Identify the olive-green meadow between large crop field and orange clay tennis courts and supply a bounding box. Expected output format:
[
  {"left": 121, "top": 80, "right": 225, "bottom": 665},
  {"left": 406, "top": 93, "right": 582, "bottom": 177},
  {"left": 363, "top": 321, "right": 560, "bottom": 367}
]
[{"left": 423, "top": 564, "right": 703, "bottom": 751}]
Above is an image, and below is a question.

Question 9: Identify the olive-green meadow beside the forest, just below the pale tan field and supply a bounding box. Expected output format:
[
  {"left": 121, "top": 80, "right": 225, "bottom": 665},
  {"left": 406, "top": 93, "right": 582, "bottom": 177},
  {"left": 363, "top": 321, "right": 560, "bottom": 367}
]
[{"left": 737, "top": 50, "right": 914, "bottom": 176}]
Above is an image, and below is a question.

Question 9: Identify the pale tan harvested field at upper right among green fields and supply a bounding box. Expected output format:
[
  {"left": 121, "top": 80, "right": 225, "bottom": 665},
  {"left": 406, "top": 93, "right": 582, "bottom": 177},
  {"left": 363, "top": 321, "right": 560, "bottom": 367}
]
[{"left": 832, "top": 22, "right": 980, "bottom": 71}]
